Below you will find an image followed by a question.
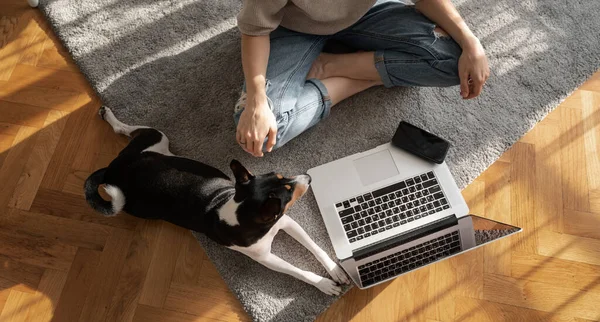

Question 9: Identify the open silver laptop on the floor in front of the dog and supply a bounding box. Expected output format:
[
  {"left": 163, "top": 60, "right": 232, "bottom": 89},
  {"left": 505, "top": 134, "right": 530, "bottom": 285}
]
[{"left": 308, "top": 143, "right": 520, "bottom": 288}]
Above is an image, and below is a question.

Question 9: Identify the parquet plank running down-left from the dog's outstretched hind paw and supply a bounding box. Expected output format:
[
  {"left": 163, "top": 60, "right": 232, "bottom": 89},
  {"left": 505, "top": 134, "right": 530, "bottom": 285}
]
[{"left": 41, "top": 97, "right": 99, "bottom": 191}]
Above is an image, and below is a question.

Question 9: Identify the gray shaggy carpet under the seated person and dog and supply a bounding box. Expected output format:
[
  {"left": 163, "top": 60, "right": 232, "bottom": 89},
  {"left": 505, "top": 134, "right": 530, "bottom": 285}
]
[{"left": 40, "top": 0, "right": 600, "bottom": 321}]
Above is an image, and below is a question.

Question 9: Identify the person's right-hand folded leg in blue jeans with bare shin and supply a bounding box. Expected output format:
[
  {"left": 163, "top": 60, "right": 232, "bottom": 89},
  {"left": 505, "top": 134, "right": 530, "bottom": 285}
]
[{"left": 311, "top": 2, "right": 462, "bottom": 87}]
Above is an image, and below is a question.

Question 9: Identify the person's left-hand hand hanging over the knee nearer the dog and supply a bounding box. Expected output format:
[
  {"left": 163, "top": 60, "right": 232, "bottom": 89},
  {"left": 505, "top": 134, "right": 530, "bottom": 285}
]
[{"left": 236, "top": 95, "right": 277, "bottom": 157}]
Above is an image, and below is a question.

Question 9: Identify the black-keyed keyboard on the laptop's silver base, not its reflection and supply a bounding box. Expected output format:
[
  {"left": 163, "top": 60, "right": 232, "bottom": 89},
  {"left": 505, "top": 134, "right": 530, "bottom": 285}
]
[{"left": 335, "top": 171, "right": 450, "bottom": 243}]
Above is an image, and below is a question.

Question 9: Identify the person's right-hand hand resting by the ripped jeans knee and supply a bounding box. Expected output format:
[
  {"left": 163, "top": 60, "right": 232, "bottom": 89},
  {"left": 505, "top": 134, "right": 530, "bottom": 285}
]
[{"left": 458, "top": 38, "right": 490, "bottom": 99}]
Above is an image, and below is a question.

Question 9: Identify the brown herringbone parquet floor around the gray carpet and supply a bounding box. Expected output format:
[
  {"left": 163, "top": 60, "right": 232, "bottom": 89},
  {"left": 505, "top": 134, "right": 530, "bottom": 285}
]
[{"left": 0, "top": 4, "right": 600, "bottom": 322}]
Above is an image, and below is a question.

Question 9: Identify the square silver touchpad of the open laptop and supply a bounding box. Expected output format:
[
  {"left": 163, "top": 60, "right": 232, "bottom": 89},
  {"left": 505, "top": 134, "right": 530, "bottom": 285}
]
[{"left": 354, "top": 150, "right": 399, "bottom": 186}]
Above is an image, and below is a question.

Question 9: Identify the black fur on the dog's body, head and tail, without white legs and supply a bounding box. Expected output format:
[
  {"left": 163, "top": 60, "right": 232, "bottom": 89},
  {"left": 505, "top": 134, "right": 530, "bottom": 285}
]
[{"left": 85, "top": 128, "right": 298, "bottom": 247}]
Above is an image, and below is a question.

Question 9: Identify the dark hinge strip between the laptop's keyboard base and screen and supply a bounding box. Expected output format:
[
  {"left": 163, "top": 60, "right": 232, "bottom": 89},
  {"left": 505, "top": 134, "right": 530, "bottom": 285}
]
[{"left": 352, "top": 214, "right": 458, "bottom": 260}]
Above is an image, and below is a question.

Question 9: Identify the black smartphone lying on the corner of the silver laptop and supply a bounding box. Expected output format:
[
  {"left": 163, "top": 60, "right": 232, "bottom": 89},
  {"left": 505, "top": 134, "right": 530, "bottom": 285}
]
[{"left": 392, "top": 121, "right": 450, "bottom": 164}]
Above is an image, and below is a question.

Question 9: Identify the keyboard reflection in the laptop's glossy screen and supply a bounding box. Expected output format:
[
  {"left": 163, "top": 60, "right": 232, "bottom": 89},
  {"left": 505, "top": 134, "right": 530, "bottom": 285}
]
[{"left": 358, "top": 231, "right": 462, "bottom": 287}]
